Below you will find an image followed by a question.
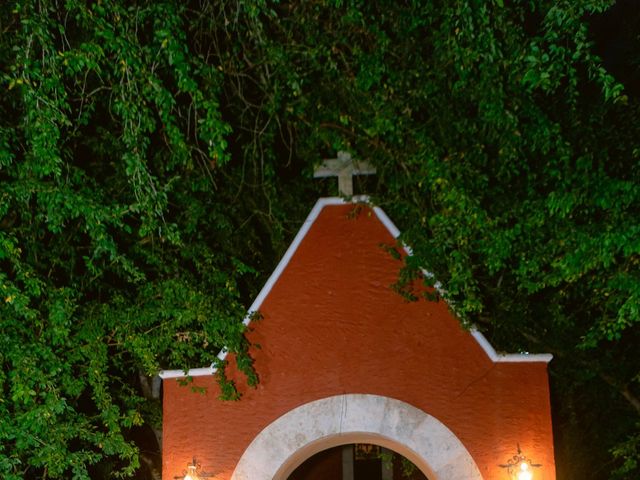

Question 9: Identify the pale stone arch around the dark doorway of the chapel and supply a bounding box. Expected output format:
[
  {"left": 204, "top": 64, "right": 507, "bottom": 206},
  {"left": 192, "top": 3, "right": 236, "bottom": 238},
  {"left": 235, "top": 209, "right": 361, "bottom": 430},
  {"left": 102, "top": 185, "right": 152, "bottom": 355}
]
[{"left": 231, "top": 394, "right": 482, "bottom": 480}]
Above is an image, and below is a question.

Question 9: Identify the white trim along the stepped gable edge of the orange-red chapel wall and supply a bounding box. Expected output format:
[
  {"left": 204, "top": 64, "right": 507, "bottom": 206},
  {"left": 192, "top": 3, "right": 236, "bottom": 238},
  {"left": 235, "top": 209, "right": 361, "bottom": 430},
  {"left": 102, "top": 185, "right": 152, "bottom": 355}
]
[{"left": 159, "top": 195, "right": 553, "bottom": 379}]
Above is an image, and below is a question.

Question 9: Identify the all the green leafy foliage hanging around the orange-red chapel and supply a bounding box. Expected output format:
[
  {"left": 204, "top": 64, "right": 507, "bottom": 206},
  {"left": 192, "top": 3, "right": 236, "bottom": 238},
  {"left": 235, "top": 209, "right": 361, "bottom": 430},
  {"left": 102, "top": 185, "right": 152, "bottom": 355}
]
[{"left": 0, "top": 0, "right": 640, "bottom": 478}]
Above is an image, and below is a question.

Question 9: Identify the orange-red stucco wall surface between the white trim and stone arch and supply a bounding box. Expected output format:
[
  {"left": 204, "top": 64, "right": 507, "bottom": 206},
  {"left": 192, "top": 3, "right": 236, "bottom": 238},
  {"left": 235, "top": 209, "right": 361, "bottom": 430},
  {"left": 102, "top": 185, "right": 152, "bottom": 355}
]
[{"left": 163, "top": 205, "right": 555, "bottom": 480}]
